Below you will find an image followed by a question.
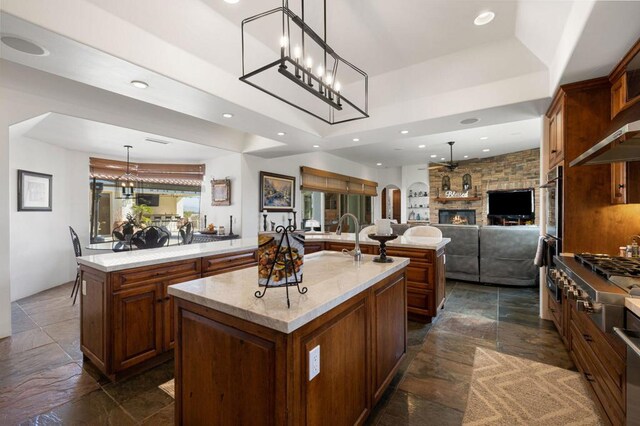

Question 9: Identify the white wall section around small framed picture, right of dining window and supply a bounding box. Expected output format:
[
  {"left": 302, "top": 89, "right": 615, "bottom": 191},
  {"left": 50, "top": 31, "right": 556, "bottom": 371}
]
[{"left": 200, "top": 153, "right": 242, "bottom": 236}]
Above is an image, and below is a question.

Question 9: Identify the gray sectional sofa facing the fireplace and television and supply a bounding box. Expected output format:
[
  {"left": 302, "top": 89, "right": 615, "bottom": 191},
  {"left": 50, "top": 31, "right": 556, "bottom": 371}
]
[{"left": 432, "top": 224, "right": 540, "bottom": 286}]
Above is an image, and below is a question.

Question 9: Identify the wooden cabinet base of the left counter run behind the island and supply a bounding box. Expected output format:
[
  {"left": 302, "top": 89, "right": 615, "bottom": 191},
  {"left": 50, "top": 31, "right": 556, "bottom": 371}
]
[{"left": 80, "top": 250, "right": 257, "bottom": 380}]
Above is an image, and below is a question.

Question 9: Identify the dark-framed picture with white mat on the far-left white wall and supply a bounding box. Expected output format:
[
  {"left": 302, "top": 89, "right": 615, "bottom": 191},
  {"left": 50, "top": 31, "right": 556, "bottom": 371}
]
[{"left": 18, "top": 170, "right": 53, "bottom": 212}]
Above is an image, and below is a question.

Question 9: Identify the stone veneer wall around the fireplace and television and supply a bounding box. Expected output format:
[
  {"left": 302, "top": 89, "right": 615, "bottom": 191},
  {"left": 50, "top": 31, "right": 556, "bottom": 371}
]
[{"left": 429, "top": 148, "right": 541, "bottom": 225}]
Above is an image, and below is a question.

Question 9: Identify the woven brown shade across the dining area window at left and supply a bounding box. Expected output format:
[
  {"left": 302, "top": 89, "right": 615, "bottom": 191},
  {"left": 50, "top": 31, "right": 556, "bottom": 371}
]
[{"left": 89, "top": 157, "right": 206, "bottom": 186}]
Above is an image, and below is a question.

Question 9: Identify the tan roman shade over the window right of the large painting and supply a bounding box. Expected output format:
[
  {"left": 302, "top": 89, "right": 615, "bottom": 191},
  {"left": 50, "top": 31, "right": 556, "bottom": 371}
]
[{"left": 300, "top": 166, "right": 378, "bottom": 197}]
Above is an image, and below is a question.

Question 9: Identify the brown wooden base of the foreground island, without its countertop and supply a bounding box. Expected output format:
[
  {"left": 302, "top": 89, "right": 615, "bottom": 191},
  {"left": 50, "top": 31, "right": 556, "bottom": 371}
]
[{"left": 174, "top": 268, "right": 407, "bottom": 426}]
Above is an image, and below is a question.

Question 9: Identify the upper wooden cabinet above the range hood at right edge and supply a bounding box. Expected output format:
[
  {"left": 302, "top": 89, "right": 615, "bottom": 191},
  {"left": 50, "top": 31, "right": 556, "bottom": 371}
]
[{"left": 609, "top": 39, "right": 640, "bottom": 119}]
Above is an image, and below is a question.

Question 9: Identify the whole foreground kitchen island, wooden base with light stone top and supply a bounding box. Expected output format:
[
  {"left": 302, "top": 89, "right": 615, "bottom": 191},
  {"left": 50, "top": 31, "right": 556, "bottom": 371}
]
[{"left": 168, "top": 251, "right": 409, "bottom": 424}]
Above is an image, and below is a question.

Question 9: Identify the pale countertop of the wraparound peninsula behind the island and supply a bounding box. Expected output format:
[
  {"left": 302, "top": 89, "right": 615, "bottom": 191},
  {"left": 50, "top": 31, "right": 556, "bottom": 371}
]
[{"left": 77, "top": 232, "right": 451, "bottom": 272}]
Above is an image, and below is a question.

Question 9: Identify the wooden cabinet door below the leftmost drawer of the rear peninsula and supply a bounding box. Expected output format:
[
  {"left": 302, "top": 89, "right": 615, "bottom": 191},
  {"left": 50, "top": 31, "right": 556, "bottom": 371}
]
[{"left": 113, "top": 284, "right": 163, "bottom": 372}]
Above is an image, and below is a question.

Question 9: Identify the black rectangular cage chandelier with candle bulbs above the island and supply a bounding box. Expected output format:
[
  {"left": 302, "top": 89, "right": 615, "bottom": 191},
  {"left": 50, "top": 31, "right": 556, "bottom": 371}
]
[{"left": 240, "top": 0, "right": 369, "bottom": 124}]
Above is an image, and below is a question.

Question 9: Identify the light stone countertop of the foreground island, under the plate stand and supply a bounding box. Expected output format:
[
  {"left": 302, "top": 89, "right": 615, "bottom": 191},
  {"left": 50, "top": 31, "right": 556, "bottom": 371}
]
[{"left": 169, "top": 251, "right": 409, "bottom": 333}]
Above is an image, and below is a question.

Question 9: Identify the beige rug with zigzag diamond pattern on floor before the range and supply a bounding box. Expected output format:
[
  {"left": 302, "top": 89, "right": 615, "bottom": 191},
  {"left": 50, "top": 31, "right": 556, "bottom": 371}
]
[{"left": 463, "top": 348, "right": 604, "bottom": 426}]
